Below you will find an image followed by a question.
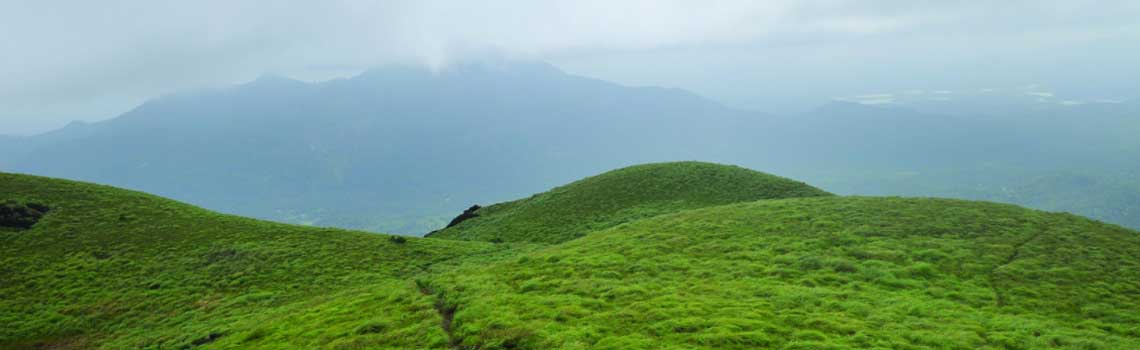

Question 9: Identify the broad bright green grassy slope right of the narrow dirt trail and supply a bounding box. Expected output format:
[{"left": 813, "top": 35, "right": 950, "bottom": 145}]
[{"left": 434, "top": 197, "right": 1140, "bottom": 349}]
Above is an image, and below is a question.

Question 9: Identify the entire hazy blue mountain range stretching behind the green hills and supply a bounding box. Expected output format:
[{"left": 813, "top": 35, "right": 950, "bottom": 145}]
[{"left": 0, "top": 63, "right": 1140, "bottom": 234}]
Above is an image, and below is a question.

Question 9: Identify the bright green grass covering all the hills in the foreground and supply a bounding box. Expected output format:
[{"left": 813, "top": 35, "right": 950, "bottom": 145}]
[{"left": 0, "top": 163, "right": 1140, "bottom": 349}]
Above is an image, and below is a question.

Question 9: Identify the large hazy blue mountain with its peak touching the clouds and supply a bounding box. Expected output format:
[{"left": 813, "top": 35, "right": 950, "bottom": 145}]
[{"left": 10, "top": 64, "right": 756, "bottom": 231}]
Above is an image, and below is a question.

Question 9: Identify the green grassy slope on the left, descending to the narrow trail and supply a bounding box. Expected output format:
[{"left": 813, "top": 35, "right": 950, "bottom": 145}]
[{"left": 0, "top": 173, "right": 508, "bottom": 349}]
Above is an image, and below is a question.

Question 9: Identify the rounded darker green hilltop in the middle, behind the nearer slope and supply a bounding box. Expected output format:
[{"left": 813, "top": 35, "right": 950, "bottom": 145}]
[{"left": 431, "top": 162, "right": 830, "bottom": 243}]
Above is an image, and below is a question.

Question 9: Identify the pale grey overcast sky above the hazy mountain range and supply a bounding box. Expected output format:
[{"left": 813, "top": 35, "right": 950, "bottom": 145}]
[{"left": 0, "top": 0, "right": 1140, "bottom": 135}]
